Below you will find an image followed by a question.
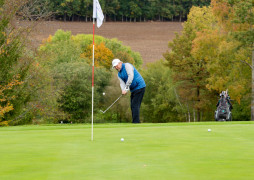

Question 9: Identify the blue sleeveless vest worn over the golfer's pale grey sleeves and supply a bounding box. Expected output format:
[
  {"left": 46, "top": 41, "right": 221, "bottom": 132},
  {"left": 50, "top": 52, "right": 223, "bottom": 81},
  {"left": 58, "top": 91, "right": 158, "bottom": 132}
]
[{"left": 118, "top": 63, "right": 146, "bottom": 92}]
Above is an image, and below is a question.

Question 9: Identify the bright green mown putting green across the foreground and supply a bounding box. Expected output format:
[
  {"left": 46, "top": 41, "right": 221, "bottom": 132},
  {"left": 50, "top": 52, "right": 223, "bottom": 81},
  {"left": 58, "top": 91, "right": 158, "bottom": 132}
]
[{"left": 0, "top": 122, "right": 254, "bottom": 180}]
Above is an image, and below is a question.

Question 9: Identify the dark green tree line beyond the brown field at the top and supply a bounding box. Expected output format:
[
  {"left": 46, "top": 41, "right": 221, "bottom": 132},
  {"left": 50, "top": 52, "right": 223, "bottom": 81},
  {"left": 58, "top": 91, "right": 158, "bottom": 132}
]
[{"left": 40, "top": 0, "right": 211, "bottom": 22}]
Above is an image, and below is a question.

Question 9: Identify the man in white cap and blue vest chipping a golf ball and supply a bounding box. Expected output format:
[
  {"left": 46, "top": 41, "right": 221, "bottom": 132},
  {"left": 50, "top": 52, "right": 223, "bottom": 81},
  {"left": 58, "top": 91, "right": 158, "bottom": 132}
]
[{"left": 112, "top": 59, "right": 146, "bottom": 123}]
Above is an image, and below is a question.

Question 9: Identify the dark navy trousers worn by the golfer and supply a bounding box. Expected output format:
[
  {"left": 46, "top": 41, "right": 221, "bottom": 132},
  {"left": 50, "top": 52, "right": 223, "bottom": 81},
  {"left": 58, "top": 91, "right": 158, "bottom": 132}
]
[{"left": 131, "top": 87, "right": 145, "bottom": 123}]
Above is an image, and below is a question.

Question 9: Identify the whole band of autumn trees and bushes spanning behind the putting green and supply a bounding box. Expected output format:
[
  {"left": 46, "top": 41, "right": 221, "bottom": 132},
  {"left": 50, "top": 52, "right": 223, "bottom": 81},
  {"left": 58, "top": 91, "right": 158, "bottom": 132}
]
[{"left": 0, "top": 0, "right": 254, "bottom": 126}]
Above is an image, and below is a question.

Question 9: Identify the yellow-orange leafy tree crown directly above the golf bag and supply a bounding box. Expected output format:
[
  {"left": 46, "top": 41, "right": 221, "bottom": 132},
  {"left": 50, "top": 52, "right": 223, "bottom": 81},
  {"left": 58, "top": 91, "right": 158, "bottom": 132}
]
[{"left": 191, "top": 29, "right": 250, "bottom": 103}]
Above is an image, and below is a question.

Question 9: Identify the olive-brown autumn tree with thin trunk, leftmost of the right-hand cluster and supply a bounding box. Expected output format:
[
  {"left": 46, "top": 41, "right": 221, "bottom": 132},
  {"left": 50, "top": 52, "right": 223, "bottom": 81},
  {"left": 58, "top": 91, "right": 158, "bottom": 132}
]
[{"left": 164, "top": 7, "right": 215, "bottom": 121}]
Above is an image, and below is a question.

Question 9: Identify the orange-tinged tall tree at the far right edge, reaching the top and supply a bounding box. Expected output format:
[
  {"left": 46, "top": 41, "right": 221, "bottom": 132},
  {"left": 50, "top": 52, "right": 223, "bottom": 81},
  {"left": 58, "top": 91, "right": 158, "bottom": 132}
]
[{"left": 211, "top": 0, "right": 254, "bottom": 120}]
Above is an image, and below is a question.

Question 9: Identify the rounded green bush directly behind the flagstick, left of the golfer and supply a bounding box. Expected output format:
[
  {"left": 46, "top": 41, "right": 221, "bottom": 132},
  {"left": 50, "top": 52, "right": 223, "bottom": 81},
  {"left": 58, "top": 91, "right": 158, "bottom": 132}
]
[{"left": 55, "top": 62, "right": 110, "bottom": 122}]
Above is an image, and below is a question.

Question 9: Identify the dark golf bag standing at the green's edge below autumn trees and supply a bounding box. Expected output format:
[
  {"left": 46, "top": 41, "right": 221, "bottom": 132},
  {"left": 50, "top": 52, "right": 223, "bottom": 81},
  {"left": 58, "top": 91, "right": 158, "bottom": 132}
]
[{"left": 214, "top": 95, "right": 232, "bottom": 121}]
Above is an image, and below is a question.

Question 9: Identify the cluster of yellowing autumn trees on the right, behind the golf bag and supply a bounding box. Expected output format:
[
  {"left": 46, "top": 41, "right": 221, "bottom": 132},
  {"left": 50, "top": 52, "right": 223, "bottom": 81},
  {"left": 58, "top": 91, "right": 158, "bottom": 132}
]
[{"left": 164, "top": 0, "right": 254, "bottom": 121}]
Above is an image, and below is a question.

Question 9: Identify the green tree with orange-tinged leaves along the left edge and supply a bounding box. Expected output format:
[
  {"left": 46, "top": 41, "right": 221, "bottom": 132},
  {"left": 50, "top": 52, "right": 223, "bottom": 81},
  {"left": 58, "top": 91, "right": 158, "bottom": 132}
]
[{"left": 0, "top": 0, "right": 31, "bottom": 125}]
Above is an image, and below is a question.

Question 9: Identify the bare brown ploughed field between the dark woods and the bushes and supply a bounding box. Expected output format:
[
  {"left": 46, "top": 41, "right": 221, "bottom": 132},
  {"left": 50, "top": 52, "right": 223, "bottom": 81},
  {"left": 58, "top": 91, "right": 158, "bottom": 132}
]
[{"left": 26, "top": 21, "right": 182, "bottom": 65}]
